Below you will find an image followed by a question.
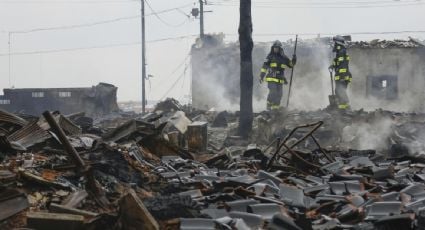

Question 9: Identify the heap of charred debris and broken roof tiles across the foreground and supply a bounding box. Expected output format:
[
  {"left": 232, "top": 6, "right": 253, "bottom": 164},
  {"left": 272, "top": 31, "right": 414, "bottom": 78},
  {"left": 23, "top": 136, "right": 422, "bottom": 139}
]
[{"left": 0, "top": 100, "right": 425, "bottom": 230}]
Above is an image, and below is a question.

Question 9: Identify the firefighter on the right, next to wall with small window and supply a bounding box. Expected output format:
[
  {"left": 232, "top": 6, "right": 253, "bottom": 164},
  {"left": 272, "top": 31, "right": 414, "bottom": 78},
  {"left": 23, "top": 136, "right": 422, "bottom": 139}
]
[{"left": 329, "top": 35, "right": 352, "bottom": 110}]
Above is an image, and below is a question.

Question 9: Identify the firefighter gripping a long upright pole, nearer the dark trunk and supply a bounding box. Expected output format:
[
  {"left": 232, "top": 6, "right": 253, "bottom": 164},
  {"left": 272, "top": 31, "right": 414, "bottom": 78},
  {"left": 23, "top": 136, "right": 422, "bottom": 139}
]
[{"left": 260, "top": 40, "right": 297, "bottom": 110}]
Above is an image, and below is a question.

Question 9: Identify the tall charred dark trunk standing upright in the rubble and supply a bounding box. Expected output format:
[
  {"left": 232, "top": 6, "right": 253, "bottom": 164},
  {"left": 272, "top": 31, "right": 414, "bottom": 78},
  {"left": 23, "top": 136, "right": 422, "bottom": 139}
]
[{"left": 239, "top": 0, "right": 254, "bottom": 139}]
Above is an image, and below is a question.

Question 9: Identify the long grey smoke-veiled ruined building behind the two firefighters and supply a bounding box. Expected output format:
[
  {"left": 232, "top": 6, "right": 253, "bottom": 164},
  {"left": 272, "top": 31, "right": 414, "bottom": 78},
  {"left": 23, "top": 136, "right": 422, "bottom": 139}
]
[{"left": 192, "top": 36, "right": 425, "bottom": 112}]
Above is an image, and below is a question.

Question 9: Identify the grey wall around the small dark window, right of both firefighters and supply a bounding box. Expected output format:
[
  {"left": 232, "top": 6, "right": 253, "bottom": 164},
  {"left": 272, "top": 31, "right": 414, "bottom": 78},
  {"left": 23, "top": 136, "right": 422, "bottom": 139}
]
[{"left": 350, "top": 48, "right": 425, "bottom": 111}]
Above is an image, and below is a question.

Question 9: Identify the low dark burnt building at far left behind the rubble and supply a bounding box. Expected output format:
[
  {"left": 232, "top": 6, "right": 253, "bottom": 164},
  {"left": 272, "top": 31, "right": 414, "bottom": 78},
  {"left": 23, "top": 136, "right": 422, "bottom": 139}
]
[{"left": 0, "top": 83, "right": 118, "bottom": 116}]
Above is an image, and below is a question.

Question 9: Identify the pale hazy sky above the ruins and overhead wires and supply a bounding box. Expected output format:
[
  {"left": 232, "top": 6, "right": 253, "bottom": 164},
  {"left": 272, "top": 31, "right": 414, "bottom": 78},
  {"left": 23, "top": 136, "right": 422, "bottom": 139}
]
[{"left": 0, "top": 0, "right": 425, "bottom": 101}]
